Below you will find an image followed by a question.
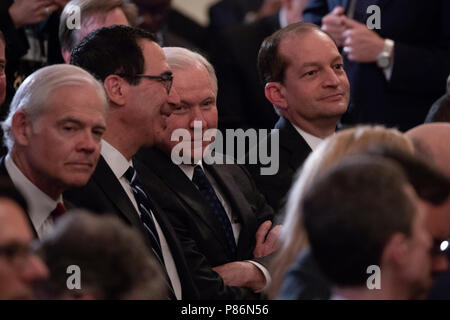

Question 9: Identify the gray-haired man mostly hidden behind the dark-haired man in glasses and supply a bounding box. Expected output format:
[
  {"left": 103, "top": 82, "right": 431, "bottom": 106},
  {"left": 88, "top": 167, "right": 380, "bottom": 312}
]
[{"left": 59, "top": 0, "right": 138, "bottom": 63}]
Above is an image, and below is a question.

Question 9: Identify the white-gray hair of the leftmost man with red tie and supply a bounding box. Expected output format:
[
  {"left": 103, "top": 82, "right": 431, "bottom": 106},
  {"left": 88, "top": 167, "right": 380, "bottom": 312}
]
[{"left": 2, "top": 64, "right": 108, "bottom": 150}]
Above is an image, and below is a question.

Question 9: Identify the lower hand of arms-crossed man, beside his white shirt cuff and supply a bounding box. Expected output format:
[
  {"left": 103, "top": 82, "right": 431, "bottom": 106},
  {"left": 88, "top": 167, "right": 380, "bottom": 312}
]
[{"left": 213, "top": 261, "right": 266, "bottom": 292}]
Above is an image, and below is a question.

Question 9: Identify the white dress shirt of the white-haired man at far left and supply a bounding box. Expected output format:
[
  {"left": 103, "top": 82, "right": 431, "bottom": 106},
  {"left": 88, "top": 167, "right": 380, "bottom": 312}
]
[{"left": 5, "top": 154, "right": 63, "bottom": 239}]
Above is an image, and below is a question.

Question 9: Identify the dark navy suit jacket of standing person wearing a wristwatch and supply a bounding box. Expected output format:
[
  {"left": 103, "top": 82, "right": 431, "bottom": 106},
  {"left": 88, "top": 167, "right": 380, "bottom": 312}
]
[{"left": 303, "top": 0, "right": 450, "bottom": 130}]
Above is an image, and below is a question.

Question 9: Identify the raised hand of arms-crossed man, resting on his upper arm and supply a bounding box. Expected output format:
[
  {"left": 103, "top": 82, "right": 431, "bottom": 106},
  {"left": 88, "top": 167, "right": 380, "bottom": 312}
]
[{"left": 253, "top": 220, "right": 281, "bottom": 258}]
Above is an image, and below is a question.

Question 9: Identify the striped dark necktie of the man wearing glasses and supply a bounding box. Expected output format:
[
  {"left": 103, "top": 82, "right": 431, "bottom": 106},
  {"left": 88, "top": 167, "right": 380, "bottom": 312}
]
[{"left": 124, "top": 167, "right": 164, "bottom": 267}]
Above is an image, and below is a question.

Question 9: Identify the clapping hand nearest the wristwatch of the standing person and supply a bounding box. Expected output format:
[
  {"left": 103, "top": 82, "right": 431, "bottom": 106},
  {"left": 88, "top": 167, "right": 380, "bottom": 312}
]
[{"left": 344, "top": 18, "right": 384, "bottom": 62}]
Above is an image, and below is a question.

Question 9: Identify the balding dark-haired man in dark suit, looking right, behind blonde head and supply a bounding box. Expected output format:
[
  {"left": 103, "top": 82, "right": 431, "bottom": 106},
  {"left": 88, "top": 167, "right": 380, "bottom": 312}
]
[{"left": 248, "top": 22, "right": 350, "bottom": 212}]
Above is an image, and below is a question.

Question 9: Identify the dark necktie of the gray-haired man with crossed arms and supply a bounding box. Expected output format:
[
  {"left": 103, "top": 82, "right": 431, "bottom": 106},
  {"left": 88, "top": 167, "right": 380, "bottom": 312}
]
[{"left": 192, "top": 166, "right": 237, "bottom": 258}]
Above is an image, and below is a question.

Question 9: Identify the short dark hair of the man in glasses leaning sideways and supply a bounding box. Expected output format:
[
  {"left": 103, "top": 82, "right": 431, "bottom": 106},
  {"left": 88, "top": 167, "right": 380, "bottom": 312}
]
[{"left": 70, "top": 25, "right": 155, "bottom": 85}]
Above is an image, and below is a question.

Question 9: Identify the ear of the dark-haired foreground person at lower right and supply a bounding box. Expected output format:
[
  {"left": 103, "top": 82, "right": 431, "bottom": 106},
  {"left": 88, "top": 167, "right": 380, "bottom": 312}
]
[{"left": 382, "top": 232, "right": 410, "bottom": 269}]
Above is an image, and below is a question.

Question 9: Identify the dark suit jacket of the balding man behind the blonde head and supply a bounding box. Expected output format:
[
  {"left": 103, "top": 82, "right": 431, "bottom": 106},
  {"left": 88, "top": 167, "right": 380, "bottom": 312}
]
[{"left": 247, "top": 117, "right": 311, "bottom": 214}]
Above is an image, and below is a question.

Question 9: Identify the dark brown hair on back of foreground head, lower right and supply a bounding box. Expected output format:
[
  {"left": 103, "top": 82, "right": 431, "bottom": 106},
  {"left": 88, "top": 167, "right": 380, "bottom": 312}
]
[{"left": 302, "top": 156, "right": 416, "bottom": 286}]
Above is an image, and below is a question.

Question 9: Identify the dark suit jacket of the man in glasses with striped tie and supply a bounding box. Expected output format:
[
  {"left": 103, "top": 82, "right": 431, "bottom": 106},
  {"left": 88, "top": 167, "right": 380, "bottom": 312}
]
[{"left": 64, "top": 157, "right": 198, "bottom": 299}]
